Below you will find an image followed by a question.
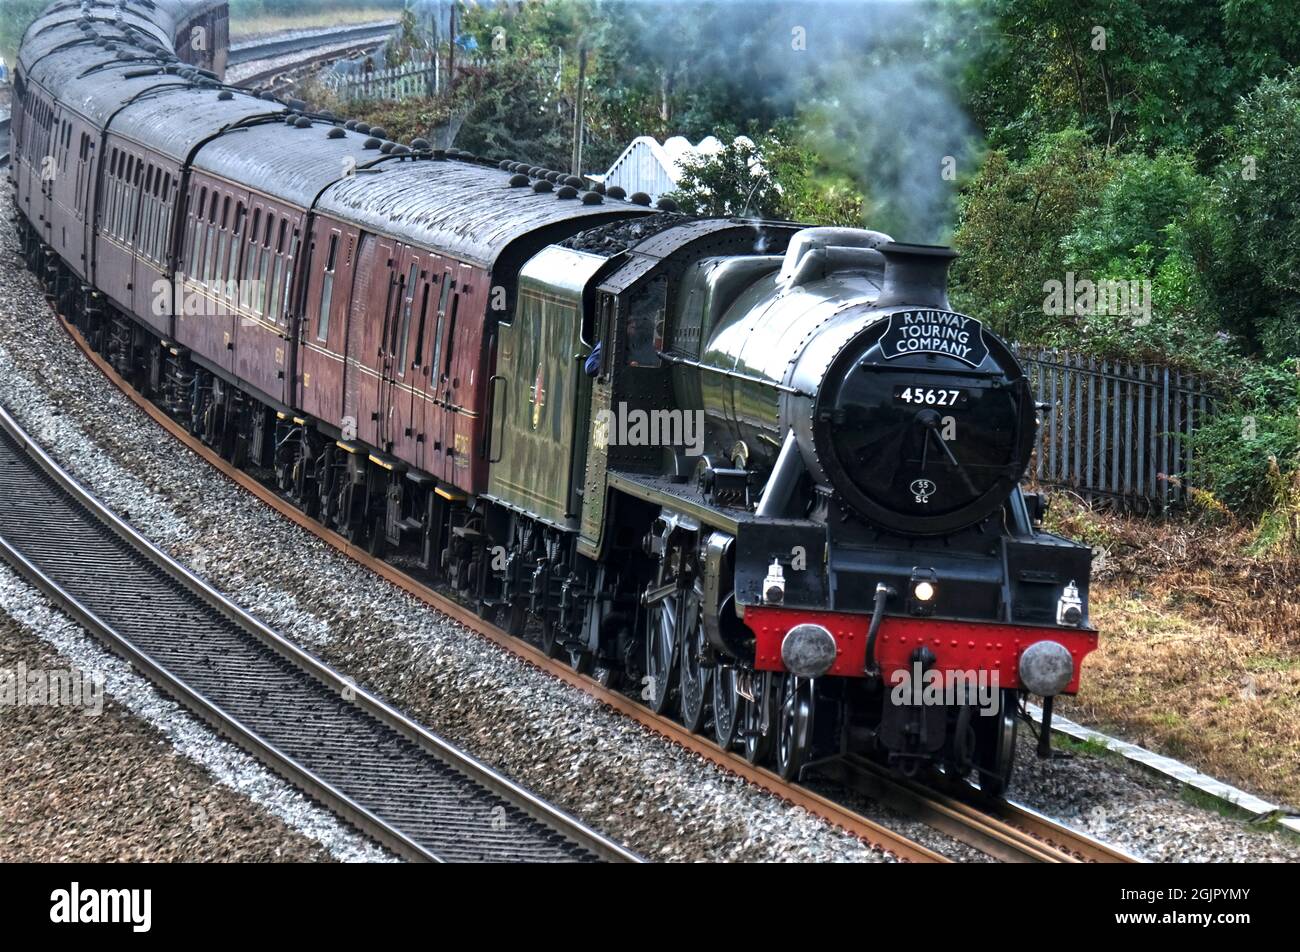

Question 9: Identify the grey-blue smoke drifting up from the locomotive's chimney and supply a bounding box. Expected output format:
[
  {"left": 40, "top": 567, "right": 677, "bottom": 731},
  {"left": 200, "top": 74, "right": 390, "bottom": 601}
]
[{"left": 601, "top": 0, "right": 982, "bottom": 242}]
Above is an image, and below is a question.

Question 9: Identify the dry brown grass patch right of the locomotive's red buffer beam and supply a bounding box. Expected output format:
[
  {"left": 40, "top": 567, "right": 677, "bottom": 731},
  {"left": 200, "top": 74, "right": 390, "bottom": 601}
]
[{"left": 1049, "top": 497, "right": 1300, "bottom": 804}]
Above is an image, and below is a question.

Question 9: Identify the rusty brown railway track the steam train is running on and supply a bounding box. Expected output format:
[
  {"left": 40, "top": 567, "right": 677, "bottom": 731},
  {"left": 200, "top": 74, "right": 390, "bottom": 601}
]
[{"left": 38, "top": 308, "right": 1136, "bottom": 862}]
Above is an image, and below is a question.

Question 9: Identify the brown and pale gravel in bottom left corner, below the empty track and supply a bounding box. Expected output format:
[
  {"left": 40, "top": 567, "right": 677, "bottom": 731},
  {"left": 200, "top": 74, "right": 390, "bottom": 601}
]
[{"left": 0, "top": 563, "right": 390, "bottom": 862}]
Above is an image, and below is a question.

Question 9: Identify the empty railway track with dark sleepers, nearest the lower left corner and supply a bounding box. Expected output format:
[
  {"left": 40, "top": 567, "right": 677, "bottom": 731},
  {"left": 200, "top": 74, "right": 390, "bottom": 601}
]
[{"left": 0, "top": 408, "right": 638, "bottom": 862}]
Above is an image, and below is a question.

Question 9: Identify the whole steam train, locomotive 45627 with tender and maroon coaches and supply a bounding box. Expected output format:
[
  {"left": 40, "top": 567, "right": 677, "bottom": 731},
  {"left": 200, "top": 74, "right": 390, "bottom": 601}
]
[{"left": 9, "top": 0, "right": 1097, "bottom": 793}]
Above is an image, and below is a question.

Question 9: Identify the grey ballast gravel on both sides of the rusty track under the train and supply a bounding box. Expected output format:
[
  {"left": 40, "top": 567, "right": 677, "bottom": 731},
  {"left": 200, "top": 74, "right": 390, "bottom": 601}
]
[{"left": 0, "top": 185, "right": 1294, "bottom": 862}]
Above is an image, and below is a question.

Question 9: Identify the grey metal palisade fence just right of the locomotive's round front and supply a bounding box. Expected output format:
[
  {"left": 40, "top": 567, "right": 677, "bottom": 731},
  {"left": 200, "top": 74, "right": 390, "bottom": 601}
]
[{"left": 1018, "top": 349, "right": 1214, "bottom": 512}]
